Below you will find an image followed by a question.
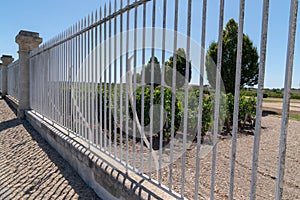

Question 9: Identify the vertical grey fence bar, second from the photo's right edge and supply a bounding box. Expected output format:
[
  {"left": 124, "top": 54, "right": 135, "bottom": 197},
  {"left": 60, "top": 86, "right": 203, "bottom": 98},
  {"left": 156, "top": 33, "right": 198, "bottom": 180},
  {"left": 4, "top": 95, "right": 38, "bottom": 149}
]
[{"left": 250, "top": 0, "right": 269, "bottom": 200}]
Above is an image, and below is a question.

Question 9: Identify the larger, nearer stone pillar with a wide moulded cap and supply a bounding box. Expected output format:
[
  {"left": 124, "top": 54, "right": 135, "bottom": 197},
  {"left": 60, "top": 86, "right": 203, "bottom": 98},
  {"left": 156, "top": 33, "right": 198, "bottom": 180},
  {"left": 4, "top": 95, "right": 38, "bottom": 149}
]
[{"left": 16, "top": 31, "right": 42, "bottom": 119}]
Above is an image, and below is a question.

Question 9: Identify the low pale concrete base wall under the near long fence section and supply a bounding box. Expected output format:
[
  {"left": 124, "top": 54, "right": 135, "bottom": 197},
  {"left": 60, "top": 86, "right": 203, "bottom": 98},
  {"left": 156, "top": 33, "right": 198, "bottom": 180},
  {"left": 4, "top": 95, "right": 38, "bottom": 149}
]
[{"left": 25, "top": 111, "right": 176, "bottom": 200}]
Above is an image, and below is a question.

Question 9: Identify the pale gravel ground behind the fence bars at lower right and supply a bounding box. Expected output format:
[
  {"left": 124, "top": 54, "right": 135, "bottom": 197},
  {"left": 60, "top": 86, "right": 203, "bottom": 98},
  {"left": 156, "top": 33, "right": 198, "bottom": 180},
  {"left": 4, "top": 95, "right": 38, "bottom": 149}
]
[{"left": 163, "top": 112, "right": 300, "bottom": 200}]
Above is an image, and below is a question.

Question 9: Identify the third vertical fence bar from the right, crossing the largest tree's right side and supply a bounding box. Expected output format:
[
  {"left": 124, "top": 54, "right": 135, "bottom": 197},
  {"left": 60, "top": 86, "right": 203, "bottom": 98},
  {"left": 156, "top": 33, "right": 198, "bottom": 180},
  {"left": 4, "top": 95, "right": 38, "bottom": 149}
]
[{"left": 229, "top": 0, "right": 245, "bottom": 200}]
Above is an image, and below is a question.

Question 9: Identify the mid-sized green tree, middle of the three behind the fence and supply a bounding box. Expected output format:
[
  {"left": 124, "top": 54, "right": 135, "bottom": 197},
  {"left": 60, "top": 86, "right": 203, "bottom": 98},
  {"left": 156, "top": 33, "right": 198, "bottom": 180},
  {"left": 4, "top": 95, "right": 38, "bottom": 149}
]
[{"left": 165, "top": 48, "right": 192, "bottom": 88}]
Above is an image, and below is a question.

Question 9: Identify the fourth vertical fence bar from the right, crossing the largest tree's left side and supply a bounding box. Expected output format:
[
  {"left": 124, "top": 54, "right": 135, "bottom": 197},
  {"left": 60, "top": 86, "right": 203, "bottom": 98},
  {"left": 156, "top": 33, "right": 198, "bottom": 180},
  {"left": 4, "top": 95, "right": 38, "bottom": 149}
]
[{"left": 210, "top": 0, "right": 224, "bottom": 199}]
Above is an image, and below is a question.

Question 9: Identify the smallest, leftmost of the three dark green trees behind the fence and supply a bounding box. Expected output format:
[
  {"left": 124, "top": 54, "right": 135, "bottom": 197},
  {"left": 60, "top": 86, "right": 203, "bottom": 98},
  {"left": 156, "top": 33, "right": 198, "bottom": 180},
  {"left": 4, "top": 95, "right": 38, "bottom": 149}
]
[{"left": 145, "top": 56, "right": 161, "bottom": 87}]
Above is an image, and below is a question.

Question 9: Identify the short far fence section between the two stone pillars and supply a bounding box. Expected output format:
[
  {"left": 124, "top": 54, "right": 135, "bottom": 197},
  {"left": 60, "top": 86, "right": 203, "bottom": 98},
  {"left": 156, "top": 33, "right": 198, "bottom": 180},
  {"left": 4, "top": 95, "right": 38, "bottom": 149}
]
[{"left": 7, "top": 60, "right": 20, "bottom": 100}]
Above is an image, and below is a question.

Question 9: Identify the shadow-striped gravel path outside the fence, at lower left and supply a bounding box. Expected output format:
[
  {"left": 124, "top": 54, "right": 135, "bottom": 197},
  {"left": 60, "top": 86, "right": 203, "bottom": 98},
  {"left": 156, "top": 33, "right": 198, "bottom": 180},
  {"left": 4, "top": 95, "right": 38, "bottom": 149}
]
[{"left": 0, "top": 98, "right": 98, "bottom": 199}]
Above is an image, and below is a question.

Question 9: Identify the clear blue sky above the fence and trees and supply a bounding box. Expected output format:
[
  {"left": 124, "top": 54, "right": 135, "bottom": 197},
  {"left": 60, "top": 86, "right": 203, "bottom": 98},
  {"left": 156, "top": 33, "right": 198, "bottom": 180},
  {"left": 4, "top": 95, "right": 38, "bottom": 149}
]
[{"left": 0, "top": 0, "right": 300, "bottom": 88}]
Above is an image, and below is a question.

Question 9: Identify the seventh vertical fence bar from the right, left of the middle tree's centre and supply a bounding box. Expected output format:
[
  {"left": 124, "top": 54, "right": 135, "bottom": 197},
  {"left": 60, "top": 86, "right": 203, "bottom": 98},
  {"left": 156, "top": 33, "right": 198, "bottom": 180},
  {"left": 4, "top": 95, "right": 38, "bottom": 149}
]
[{"left": 169, "top": 0, "right": 178, "bottom": 190}]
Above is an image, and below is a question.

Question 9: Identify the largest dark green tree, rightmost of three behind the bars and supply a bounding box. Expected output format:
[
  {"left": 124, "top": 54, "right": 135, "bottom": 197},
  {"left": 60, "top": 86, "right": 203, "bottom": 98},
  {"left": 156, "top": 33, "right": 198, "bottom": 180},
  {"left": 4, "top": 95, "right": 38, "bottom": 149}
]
[{"left": 206, "top": 19, "right": 259, "bottom": 94}]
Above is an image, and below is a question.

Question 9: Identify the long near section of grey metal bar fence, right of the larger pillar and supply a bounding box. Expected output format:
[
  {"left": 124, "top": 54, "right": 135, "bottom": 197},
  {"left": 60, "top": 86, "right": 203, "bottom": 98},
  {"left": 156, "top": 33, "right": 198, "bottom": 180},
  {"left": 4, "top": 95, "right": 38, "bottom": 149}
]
[{"left": 28, "top": 0, "right": 298, "bottom": 199}]
